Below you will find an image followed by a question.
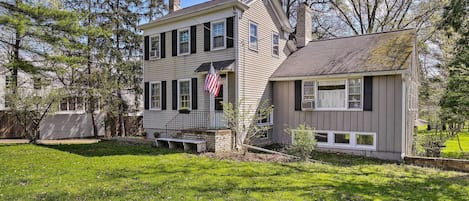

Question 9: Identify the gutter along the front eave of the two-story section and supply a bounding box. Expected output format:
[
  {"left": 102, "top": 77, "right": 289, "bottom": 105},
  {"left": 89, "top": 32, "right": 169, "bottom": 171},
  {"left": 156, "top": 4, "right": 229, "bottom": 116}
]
[{"left": 137, "top": 1, "right": 249, "bottom": 30}]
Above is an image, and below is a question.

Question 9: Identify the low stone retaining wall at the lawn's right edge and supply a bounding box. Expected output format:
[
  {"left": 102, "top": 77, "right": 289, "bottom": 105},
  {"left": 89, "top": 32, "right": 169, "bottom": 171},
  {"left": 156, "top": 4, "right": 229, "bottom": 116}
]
[{"left": 404, "top": 156, "right": 469, "bottom": 172}]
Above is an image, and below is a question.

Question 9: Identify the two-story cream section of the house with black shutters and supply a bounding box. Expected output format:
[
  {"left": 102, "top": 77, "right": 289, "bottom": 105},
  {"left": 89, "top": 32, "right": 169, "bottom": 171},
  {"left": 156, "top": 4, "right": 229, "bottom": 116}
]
[{"left": 140, "top": 0, "right": 293, "bottom": 137}]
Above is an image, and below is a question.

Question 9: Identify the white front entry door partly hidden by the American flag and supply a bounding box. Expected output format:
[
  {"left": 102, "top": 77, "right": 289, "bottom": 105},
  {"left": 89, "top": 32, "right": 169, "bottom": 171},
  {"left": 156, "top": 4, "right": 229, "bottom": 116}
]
[{"left": 210, "top": 76, "right": 228, "bottom": 128}]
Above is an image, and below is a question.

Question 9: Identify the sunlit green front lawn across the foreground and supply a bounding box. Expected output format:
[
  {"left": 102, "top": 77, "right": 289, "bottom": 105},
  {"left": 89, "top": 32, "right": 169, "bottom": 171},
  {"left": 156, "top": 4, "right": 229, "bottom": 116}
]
[{"left": 0, "top": 142, "right": 469, "bottom": 200}]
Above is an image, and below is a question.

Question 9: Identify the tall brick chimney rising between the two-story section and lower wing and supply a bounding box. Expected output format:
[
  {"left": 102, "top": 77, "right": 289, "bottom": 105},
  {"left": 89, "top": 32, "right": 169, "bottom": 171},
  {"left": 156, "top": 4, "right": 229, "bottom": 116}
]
[{"left": 295, "top": 3, "right": 312, "bottom": 48}]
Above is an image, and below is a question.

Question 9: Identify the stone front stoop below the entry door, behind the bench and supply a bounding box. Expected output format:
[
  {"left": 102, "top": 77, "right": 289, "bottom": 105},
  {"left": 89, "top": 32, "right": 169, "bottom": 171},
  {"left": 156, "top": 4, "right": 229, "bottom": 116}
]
[{"left": 171, "top": 130, "right": 233, "bottom": 153}]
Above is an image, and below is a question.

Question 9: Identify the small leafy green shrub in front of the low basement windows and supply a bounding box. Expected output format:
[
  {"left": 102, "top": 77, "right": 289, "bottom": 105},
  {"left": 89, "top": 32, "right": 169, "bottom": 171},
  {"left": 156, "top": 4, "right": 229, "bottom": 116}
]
[{"left": 285, "top": 124, "right": 316, "bottom": 160}]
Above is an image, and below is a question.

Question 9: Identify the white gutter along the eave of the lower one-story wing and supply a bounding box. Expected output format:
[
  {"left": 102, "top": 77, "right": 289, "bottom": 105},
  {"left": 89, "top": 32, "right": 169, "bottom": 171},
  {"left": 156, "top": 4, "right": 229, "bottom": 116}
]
[{"left": 269, "top": 69, "right": 409, "bottom": 81}]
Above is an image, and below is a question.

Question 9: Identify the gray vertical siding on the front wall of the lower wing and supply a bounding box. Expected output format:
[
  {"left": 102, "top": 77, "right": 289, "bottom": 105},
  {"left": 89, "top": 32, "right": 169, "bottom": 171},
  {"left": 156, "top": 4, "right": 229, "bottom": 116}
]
[{"left": 273, "top": 75, "right": 402, "bottom": 153}]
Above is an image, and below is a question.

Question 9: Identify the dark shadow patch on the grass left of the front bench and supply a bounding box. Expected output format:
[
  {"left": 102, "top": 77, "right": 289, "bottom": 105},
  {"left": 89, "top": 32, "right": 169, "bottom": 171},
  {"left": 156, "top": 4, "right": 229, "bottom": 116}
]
[{"left": 39, "top": 141, "right": 180, "bottom": 157}]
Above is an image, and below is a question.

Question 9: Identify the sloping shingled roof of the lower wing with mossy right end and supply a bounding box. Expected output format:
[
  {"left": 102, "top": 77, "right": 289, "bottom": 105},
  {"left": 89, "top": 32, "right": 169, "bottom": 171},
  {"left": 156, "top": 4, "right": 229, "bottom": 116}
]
[{"left": 271, "top": 29, "right": 415, "bottom": 80}]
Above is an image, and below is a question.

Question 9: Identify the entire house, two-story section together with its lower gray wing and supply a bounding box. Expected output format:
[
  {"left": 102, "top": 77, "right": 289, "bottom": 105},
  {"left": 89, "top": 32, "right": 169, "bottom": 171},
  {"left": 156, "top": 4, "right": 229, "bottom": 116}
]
[{"left": 140, "top": 0, "right": 418, "bottom": 160}]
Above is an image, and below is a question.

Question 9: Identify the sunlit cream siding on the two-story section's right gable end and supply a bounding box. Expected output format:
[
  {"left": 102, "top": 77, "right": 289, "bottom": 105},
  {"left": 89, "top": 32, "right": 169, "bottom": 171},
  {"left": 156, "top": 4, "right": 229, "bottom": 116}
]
[{"left": 238, "top": 1, "right": 290, "bottom": 133}]
